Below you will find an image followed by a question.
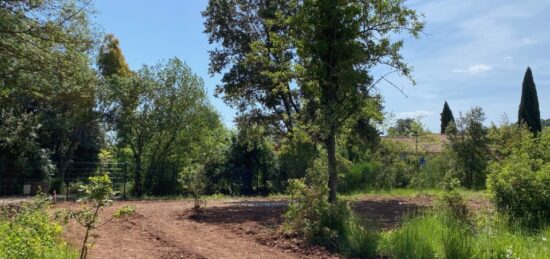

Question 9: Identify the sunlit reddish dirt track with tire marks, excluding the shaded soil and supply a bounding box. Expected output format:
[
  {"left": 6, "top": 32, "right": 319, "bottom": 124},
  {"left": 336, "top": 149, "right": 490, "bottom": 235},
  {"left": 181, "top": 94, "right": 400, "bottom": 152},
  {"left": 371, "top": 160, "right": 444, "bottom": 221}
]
[{"left": 64, "top": 201, "right": 302, "bottom": 259}]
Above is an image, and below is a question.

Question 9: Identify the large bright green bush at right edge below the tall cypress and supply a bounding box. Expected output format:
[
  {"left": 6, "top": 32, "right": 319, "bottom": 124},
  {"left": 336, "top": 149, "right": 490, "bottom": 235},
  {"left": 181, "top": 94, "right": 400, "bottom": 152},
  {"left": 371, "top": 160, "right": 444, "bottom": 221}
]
[{"left": 488, "top": 128, "right": 550, "bottom": 228}]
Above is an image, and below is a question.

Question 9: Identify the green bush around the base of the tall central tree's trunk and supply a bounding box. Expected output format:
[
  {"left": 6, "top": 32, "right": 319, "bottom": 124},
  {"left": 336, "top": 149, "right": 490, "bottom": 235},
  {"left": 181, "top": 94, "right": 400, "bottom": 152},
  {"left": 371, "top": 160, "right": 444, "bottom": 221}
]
[{"left": 283, "top": 157, "right": 378, "bottom": 258}]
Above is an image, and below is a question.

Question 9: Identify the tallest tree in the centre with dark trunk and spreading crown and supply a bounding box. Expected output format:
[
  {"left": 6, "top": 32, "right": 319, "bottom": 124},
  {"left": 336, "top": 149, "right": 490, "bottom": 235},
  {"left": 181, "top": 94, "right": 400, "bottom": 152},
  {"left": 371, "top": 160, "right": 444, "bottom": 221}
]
[{"left": 203, "top": 0, "right": 423, "bottom": 202}]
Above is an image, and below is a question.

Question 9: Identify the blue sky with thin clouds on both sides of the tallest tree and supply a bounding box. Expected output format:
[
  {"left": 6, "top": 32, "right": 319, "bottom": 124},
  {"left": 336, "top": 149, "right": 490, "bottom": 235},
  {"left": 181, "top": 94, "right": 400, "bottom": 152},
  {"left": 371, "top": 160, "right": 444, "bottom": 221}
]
[{"left": 95, "top": 0, "right": 550, "bottom": 131}]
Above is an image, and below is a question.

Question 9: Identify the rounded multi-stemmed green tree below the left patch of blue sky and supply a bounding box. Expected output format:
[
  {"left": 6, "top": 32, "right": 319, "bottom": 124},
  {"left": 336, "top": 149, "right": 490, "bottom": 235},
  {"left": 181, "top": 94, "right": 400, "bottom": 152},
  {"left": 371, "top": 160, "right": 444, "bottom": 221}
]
[{"left": 100, "top": 56, "right": 227, "bottom": 195}]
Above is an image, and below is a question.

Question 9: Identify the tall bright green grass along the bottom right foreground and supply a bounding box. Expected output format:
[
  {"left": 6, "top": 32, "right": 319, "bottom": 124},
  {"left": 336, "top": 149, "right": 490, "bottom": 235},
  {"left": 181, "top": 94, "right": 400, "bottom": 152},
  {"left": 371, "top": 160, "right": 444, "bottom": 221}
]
[{"left": 379, "top": 212, "right": 550, "bottom": 259}]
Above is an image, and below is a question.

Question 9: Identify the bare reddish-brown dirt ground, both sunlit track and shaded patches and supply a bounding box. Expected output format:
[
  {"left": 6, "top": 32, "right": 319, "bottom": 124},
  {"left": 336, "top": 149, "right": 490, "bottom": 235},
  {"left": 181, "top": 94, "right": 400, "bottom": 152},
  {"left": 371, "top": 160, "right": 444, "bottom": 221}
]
[{"left": 57, "top": 196, "right": 492, "bottom": 258}]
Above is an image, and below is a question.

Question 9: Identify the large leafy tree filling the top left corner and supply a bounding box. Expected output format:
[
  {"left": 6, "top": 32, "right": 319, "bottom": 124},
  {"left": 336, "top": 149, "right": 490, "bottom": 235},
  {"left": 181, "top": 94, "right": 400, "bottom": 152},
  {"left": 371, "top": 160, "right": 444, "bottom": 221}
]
[{"left": 0, "top": 0, "right": 98, "bottom": 187}]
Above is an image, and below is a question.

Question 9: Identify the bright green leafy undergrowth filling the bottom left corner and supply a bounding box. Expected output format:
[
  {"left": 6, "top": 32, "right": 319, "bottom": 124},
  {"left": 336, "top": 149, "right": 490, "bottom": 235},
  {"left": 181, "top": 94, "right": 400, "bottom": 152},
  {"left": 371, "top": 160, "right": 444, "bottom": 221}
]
[{"left": 0, "top": 198, "right": 78, "bottom": 259}]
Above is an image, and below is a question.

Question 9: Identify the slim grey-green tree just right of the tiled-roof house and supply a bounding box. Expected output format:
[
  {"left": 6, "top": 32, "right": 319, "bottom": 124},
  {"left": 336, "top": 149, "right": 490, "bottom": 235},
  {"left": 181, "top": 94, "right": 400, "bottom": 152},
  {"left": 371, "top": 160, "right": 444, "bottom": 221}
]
[{"left": 447, "top": 107, "right": 490, "bottom": 189}]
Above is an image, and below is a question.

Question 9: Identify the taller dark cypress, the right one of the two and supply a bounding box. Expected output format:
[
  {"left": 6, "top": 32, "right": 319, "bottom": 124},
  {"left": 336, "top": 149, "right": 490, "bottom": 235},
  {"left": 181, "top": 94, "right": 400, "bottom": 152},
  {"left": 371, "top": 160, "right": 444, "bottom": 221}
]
[{"left": 518, "top": 67, "right": 542, "bottom": 133}]
